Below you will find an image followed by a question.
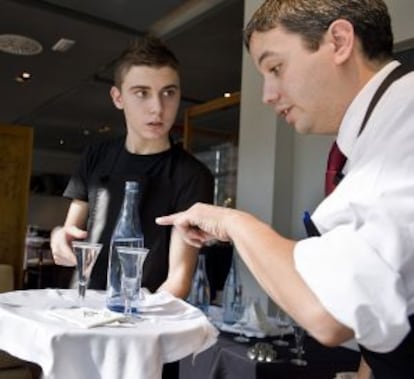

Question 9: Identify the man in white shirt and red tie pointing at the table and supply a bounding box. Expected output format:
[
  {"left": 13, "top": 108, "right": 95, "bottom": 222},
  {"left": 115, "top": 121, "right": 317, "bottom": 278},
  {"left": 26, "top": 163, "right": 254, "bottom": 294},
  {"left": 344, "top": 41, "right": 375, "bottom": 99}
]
[{"left": 157, "top": 0, "right": 414, "bottom": 379}]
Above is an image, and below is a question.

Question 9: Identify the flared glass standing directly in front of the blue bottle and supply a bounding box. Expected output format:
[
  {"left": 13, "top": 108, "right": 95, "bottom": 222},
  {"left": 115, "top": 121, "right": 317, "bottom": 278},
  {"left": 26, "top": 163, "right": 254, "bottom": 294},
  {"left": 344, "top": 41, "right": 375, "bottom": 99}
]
[{"left": 116, "top": 246, "right": 149, "bottom": 321}]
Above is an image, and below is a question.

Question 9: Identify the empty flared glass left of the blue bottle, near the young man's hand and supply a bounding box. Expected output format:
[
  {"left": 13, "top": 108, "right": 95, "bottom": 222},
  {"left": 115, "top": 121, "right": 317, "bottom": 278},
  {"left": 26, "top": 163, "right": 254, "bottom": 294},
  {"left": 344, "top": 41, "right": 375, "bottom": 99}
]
[{"left": 72, "top": 241, "right": 102, "bottom": 307}]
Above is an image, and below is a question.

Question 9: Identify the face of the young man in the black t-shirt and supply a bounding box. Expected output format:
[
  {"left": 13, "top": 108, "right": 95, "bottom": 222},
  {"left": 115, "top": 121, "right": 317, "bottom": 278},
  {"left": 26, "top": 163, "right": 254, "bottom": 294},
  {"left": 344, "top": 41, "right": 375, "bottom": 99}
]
[{"left": 111, "top": 66, "right": 181, "bottom": 142}]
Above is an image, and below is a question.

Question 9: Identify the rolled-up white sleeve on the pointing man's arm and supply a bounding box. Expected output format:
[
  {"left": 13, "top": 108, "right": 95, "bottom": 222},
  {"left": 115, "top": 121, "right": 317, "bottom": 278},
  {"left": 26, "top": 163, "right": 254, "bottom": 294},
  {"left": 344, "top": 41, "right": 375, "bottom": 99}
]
[{"left": 294, "top": 206, "right": 414, "bottom": 352}]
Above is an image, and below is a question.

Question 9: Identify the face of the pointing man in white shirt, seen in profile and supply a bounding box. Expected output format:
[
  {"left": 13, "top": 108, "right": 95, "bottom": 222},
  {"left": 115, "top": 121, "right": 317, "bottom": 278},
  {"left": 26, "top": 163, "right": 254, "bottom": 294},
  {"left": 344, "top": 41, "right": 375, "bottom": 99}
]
[{"left": 250, "top": 27, "right": 343, "bottom": 134}]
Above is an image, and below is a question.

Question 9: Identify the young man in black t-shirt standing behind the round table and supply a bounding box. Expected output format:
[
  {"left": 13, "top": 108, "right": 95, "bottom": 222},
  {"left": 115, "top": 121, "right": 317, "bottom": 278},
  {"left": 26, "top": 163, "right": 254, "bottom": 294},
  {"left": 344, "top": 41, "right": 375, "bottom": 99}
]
[{"left": 51, "top": 37, "right": 213, "bottom": 298}]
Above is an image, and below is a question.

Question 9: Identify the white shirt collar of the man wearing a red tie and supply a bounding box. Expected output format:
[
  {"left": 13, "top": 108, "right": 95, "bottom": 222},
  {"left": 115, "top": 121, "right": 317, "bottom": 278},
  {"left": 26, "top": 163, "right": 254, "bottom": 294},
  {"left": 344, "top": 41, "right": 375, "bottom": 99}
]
[{"left": 336, "top": 60, "right": 400, "bottom": 157}]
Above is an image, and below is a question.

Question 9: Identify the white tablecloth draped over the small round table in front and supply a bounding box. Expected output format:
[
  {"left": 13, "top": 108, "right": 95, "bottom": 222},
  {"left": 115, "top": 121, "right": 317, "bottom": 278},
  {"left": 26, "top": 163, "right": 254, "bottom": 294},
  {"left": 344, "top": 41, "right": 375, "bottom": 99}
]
[{"left": 0, "top": 289, "right": 218, "bottom": 379}]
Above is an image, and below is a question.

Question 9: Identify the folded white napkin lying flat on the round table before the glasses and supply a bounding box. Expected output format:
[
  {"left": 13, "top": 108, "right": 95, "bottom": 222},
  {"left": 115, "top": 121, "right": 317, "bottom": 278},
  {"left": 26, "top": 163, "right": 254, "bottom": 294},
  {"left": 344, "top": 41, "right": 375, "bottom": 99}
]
[{"left": 48, "top": 307, "right": 124, "bottom": 328}]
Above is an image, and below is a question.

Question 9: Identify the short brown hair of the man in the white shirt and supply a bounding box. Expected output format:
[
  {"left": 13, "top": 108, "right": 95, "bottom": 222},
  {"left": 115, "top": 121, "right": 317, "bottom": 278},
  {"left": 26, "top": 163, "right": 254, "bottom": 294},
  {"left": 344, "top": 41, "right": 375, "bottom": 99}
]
[{"left": 244, "top": 0, "right": 393, "bottom": 61}]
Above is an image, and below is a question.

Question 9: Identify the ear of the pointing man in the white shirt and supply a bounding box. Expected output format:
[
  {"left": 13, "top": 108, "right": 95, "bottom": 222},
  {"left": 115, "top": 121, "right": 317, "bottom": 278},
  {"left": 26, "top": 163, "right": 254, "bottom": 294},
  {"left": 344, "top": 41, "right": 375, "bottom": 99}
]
[{"left": 328, "top": 19, "right": 355, "bottom": 64}]
